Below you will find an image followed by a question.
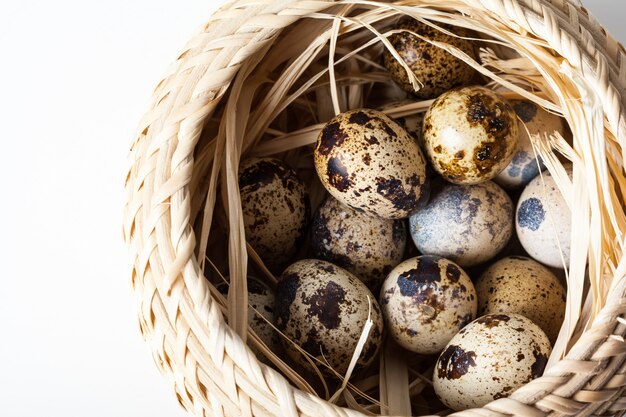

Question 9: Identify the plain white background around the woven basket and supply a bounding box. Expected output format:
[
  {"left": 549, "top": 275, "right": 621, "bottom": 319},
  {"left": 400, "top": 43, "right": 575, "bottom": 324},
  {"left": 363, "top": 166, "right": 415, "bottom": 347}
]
[{"left": 0, "top": 0, "right": 626, "bottom": 417}]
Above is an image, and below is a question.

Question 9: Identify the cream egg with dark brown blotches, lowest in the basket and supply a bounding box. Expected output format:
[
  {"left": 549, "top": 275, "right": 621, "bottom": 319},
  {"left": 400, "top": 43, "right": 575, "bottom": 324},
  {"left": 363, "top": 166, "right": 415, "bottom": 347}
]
[{"left": 433, "top": 314, "right": 552, "bottom": 411}]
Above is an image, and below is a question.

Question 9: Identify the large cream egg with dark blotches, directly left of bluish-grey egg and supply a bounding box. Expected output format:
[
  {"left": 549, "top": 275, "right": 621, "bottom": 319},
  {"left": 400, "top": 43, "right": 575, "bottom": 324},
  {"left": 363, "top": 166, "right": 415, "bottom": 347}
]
[{"left": 314, "top": 109, "right": 426, "bottom": 219}]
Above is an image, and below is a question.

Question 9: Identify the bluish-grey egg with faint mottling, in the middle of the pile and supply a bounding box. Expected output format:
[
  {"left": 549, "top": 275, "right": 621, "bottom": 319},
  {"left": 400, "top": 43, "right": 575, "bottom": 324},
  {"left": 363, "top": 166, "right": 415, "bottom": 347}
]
[{"left": 409, "top": 181, "right": 513, "bottom": 267}]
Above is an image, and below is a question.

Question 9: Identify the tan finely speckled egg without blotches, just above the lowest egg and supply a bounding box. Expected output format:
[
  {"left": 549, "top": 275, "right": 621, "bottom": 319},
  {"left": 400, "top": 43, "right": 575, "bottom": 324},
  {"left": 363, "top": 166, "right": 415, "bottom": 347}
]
[{"left": 476, "top": 256, "right": 565, "bottom": 343}]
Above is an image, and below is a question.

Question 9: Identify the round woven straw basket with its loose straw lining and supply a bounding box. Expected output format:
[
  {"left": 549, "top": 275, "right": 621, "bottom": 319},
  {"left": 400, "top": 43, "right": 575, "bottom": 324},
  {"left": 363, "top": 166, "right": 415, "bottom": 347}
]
[{"left": 124, "top": 0, "right": 626, "bottom": 417}]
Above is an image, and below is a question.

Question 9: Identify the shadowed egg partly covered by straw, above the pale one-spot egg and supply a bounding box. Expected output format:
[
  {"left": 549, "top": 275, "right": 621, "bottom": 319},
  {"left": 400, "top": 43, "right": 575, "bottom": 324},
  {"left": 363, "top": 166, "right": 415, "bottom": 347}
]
[{"left": 494, "top": 100, "right": 565, "bottom": 189}]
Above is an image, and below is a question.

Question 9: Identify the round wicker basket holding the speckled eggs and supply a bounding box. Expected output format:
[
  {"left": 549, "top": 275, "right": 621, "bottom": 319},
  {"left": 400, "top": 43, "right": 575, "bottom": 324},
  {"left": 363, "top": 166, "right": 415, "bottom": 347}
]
[{"left": 124, "top": 0, "right": 626, "bottom": 417}]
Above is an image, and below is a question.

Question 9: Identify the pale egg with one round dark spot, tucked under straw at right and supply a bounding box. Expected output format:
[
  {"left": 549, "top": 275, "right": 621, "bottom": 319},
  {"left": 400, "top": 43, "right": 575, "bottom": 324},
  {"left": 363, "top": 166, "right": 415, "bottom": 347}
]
[{"left": 515, "top": 165, "right": 572, "bottom": 268}]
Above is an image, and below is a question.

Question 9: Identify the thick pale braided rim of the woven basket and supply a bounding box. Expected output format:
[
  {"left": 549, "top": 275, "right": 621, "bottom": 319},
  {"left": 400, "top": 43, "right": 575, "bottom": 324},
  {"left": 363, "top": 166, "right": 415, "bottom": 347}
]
[{"left": 124, "top": 0, "right": 626, "bottom": 416}]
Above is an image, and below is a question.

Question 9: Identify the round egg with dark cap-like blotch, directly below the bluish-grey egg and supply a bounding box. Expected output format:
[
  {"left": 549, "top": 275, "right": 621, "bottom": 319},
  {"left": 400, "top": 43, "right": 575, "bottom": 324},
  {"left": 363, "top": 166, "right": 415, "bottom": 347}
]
[{"left": 380, "top": 255, "right": 477, "bottom": 354}]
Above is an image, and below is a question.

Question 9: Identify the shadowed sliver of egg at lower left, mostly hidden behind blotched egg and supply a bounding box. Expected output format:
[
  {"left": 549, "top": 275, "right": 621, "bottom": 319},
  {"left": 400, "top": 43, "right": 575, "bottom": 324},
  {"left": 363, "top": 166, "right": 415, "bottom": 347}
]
[{"left": 215, "top": 275, "right": 280, "bottom": 356}]
